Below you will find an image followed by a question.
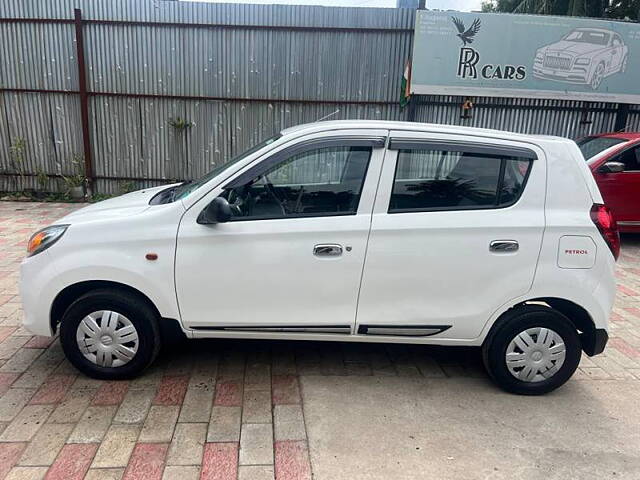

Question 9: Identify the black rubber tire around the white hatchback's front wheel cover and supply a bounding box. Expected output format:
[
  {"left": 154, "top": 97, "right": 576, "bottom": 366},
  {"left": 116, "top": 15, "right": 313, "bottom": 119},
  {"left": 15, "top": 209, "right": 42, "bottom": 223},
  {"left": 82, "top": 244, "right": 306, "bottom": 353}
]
[{"left": 60, "top": 289, "right": 161, "bottom": 380}]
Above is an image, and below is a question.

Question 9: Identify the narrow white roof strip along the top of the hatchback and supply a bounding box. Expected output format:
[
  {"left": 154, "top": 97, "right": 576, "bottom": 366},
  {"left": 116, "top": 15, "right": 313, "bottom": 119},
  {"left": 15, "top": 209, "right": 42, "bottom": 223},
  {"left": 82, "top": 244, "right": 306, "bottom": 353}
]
[{"left": 281, "top": 120, "right": 570, "bottom": 142}]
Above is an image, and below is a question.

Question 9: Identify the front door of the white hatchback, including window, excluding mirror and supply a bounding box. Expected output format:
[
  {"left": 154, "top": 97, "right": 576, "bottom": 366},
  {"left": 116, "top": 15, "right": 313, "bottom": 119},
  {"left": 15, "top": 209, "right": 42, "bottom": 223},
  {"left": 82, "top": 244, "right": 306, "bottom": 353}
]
[{"left": 175, "top": 131, "right": 386, "bottom": 335}]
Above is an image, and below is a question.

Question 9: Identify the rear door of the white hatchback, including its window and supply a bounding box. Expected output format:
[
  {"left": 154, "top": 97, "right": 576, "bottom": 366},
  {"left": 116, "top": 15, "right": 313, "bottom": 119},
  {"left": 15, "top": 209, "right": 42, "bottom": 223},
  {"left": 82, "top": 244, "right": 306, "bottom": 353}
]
[{"left": 357, "top": 131, "right": 546, "bottom": 339}]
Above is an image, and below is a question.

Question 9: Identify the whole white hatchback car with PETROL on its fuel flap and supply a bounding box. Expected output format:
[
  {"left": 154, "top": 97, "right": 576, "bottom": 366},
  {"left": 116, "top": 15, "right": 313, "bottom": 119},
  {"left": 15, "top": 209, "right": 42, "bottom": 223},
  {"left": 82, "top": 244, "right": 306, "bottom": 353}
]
[{"left": 21, "top": 121, "right": 620, "bottom": 394}]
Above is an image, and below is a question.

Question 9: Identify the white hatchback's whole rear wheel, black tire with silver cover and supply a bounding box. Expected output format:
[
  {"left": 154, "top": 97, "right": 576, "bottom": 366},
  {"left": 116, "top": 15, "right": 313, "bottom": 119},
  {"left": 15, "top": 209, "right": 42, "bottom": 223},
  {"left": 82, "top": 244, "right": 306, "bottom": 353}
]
[{"left": 483, "top": 305, "right": 582, "bottom": 395}]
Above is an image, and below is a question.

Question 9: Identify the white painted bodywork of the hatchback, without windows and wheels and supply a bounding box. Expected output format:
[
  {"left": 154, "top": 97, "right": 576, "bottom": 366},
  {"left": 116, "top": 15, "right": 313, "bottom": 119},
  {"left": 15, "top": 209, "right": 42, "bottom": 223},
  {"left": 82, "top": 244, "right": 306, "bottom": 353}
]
[{"left": 21, "top": 121, "right": 615, "bottom": 345}]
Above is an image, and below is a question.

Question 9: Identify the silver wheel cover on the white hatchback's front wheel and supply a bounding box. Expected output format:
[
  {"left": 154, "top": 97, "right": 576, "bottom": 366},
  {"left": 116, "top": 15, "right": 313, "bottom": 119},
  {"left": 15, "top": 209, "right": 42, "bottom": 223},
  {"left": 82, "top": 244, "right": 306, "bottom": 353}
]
[{"left": 76, "top": 310, "right": 139, "bottom": 367}]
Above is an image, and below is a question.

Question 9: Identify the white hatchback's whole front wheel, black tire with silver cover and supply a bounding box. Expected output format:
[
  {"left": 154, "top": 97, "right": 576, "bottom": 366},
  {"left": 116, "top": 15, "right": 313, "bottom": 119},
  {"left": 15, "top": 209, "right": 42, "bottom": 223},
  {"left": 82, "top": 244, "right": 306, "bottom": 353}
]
[{"left": 60, "top": 289, "right": 160, "bottom": 380}]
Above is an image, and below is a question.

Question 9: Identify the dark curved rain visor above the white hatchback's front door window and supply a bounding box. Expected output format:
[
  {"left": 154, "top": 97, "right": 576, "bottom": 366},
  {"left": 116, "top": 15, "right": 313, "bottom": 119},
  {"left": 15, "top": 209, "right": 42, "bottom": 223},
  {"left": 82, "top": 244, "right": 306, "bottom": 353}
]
[{"left": 223, "top": 136, "right": 387, "bottom": 190}]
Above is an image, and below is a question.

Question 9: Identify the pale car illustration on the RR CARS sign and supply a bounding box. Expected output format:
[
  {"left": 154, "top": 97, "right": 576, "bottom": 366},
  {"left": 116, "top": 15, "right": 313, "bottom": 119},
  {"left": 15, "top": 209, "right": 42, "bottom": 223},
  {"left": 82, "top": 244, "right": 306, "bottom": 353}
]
[{"left": 533, "top": 28, "right": 629, "bottom": 90}]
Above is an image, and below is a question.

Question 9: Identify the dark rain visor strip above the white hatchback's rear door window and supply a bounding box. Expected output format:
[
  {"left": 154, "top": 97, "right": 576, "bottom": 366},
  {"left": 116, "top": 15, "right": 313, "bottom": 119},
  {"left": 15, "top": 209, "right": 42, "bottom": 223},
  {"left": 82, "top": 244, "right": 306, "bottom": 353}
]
[{"left": 388, "top": 137, "right": 538, "bottom": 160}]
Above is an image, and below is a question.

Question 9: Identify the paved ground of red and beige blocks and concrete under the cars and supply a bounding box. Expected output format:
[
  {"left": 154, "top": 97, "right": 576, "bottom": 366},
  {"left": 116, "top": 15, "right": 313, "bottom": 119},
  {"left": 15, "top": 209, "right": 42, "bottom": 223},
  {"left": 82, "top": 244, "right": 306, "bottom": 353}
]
[{"left": 0, "top": 202, "right": 640, "bottom": 480}]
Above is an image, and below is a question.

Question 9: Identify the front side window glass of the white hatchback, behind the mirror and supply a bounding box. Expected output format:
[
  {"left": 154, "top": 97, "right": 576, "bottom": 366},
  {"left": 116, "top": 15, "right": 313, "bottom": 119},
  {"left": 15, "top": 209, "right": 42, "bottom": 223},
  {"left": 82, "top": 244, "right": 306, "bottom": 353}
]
[{"left": 222, "top": 147, "right": 371, "bottom": 221}]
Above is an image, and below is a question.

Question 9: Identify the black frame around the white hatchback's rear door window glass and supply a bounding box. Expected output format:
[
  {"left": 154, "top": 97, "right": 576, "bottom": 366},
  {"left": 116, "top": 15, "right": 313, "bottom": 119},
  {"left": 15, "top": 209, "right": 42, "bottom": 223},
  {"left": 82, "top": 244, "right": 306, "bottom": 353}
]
[{"left": 387, "top": 146, "right": 538, "bottom": 215}]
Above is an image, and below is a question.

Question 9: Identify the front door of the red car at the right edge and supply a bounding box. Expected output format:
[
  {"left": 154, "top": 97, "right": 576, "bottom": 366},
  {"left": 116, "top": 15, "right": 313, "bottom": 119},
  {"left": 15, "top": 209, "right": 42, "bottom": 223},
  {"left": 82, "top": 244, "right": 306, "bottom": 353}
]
[{"left": 595, "top": 145, "right": 640, "bottom": 227}]
